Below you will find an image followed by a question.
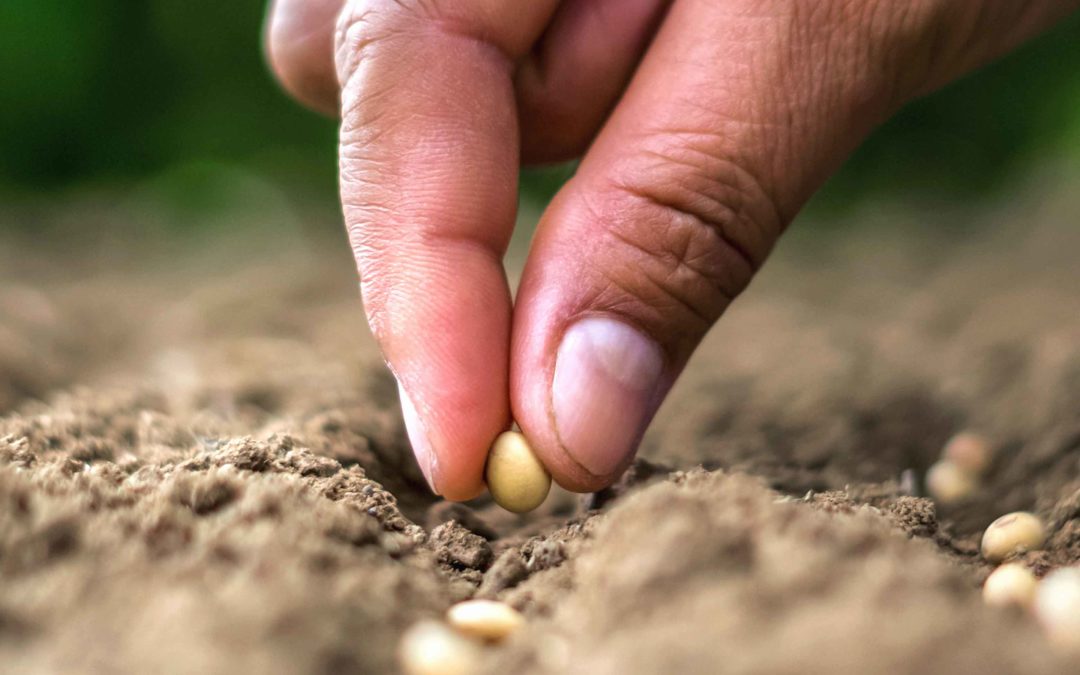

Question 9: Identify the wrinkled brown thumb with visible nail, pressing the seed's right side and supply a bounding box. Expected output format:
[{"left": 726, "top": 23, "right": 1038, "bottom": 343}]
[{"left": 510, "top": 0, "right": 1080, "bottom": 491}]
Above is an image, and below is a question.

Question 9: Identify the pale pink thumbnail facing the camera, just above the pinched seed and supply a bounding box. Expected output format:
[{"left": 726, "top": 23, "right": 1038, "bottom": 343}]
[{"left": 552, "top": 318, "right": 663, "bottom": 476}]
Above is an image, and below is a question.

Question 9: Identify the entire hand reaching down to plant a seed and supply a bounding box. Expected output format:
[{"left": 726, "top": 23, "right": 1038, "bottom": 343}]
[{"left": 268, "top": 0, "right": 1080, "bottom": 499}]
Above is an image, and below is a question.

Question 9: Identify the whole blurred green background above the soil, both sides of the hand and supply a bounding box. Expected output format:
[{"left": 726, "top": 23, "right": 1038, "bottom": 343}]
[{"left": 0, "top": 0, "right": 1080, "bottom": 227}]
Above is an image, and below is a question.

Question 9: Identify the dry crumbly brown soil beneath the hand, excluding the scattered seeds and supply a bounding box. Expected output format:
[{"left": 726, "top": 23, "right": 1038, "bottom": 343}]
[{"left": 0, "top": 176, "right": 1080, "bottom": 675}]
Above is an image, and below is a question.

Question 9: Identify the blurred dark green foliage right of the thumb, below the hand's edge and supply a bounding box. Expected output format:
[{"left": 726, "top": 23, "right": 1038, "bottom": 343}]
[{"left": 816, "top": 15, "right": 1080, "bottom": 212}]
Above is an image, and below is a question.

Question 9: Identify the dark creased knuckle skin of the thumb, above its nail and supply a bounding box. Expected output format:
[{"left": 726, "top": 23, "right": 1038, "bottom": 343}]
[{"left": 603, "top": 140, "right": 780, "bottom": 329}]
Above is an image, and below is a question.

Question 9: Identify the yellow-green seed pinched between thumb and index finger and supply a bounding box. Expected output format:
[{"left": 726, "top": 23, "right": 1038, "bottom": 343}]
[{"left": 485, "top": 431, "right": 551, "bottom": 513}]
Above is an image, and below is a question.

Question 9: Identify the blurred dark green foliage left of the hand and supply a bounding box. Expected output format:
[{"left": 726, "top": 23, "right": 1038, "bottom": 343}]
[{"left": 0, "top": 0, "right": 336, "bottom": 192}]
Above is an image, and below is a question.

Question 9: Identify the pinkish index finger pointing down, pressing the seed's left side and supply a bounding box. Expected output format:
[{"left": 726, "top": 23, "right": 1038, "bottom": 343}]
[{"left": 335, "top": 0, "right": 557, "bottom": 499}]
